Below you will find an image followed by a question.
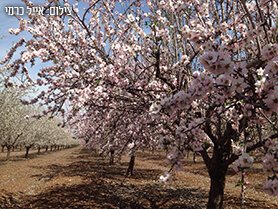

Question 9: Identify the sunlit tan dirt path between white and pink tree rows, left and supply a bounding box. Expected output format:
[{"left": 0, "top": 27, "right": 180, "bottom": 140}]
[{"left": 0, "top": 146, "right": 81, "bottom": 195}]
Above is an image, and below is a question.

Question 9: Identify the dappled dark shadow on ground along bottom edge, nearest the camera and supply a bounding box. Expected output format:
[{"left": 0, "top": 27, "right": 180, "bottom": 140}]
[{"left": 15, "top": 180, "right": 206, "bottom": 209}]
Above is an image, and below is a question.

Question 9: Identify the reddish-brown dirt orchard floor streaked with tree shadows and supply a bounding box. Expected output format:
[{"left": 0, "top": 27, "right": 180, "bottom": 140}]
[{"left": 0, "top": 146, "right": 278, "bottom": 209}]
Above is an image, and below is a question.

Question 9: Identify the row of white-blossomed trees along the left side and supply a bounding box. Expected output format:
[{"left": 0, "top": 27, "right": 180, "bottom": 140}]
[{"left": 0, "top": 78, "right": 78, "bottom": 159}]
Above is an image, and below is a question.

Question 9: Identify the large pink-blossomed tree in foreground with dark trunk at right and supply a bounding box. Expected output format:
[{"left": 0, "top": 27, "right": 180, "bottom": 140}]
[{"left": 2, "top": 0, "right": 278, "bottom": 208}]
